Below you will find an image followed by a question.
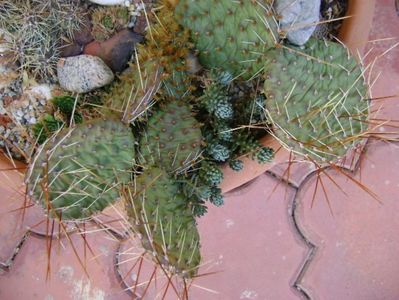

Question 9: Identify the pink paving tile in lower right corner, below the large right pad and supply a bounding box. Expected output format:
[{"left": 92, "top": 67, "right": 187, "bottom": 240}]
[{"left": 295, "top": 142, "right": 399, "bottom": 300}]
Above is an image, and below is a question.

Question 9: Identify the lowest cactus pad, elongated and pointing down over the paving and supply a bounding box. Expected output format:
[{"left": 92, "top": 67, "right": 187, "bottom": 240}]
[{"left": 126, "top": 167, "right": 201, "bottom": 278}]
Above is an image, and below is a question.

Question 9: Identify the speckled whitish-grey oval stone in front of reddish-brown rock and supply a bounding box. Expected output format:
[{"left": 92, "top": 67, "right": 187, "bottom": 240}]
[{"left": 57, "top": 55, "right": 114, "bottom": 93}]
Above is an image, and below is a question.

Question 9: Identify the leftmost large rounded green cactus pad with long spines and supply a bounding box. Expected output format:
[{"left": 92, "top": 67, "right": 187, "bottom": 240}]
[{"left": 27, "top": 120, "right": 134, "bottom": 220}]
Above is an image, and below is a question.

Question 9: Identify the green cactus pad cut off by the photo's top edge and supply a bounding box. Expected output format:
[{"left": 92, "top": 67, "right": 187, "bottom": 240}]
[{"left": 175, "top": 0, "right": 278, "bottom": 79}]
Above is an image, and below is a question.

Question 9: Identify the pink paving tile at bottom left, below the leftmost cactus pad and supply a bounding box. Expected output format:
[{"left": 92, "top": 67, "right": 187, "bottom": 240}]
[{"left": 0, "top": 225, "right": 130, "bottom": 300}]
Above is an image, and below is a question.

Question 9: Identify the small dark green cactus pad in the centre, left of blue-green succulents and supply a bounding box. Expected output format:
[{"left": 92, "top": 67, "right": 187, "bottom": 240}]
[{"left": 140, "top": 101, "right": 202, "bottom": 172}]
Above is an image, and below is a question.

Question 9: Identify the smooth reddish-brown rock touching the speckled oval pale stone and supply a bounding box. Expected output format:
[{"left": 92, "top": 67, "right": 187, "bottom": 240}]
[{"left": 83, "top": 29, "right": 143, "bottom": 72}]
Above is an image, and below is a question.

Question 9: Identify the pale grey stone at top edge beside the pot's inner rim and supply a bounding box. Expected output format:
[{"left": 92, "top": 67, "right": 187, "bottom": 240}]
[{"left": 275, "top": 0, "right": 321, "bottom": 46}]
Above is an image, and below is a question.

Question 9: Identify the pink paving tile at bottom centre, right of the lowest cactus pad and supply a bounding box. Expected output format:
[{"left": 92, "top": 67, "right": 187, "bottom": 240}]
[{"left": 190, "top": 174, "right": 308, "bottom": 299}]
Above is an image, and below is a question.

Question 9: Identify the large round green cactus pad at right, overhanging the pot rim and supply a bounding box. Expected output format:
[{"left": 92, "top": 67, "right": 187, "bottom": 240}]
[{"left": 264, "top": 40, "right": 369, "bottom": 161}]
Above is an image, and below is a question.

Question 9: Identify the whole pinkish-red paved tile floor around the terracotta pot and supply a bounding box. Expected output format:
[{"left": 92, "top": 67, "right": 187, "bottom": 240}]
[{"left": 0, "top": 0, "right": 399, "bottom": 300}]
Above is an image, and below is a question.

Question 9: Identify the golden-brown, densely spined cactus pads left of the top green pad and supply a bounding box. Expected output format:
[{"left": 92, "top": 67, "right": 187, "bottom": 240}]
[{"left": 105, "top": 1, "right": 191, "bottom": 123}]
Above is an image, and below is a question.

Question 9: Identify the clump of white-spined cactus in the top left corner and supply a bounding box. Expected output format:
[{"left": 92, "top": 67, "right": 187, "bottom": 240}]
[{"left": 0, "top": 0, "right": 83, "bottom": 80}]
